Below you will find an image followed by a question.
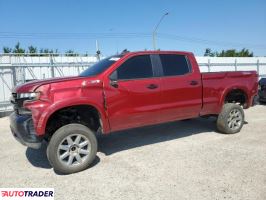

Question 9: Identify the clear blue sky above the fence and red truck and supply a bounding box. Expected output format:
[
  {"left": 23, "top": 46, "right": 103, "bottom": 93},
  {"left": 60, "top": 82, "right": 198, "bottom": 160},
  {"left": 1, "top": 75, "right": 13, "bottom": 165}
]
[{"left": 0, "top": 0, "right": 266, "bottom": 56}]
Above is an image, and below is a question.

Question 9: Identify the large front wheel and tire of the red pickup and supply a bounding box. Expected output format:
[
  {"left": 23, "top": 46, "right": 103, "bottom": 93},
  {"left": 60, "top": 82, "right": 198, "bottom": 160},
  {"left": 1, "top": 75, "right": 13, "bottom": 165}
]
[{"left": 47, "top": 124, "right": 97, "bottom": 174}]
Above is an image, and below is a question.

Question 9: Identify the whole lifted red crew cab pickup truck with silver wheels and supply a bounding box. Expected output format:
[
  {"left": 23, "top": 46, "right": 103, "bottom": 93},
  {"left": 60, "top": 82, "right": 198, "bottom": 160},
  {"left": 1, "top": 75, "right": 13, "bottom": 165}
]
[{"left": 10, "top": 51, "right": 258, "bottom": 173}]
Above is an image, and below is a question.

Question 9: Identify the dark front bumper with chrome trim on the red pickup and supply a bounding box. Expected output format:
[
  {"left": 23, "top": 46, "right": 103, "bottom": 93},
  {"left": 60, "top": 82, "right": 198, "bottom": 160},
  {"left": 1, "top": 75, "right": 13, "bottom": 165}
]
[{"left": 9, "top": 112, "right": 43, "bottom": 149}]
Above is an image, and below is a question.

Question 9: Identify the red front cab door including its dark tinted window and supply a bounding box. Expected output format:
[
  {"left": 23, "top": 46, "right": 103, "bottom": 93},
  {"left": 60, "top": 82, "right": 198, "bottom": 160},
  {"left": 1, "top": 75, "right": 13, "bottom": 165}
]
[{"left": 104, "top": 55, "right": 161, "bottom": 131}]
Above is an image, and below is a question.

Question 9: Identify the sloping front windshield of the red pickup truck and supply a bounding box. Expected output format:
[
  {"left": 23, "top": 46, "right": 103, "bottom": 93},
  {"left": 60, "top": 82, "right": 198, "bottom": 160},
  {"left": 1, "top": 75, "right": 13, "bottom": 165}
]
[{"left": 79, "top": 55, "right": 122, "bottom": 76}]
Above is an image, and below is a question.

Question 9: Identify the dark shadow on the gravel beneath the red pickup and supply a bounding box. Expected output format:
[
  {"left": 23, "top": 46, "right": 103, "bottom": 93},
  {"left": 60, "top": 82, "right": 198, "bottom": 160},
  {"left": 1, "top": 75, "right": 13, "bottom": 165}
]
[{"left": 25, "top": 118, "right": 216, "bottom": 169}]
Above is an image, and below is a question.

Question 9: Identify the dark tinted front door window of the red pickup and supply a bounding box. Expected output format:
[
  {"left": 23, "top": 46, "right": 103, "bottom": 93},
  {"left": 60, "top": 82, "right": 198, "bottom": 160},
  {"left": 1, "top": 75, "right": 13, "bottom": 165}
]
[{"left": 117, "top": 55, "right": 153, "bottom": 79}]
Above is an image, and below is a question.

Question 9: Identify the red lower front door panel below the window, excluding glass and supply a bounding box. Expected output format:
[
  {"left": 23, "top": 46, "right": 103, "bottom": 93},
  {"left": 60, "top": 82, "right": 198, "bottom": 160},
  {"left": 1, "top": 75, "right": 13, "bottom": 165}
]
[{"left": 104, "top": 78, "right": 161, "bottom": 131}]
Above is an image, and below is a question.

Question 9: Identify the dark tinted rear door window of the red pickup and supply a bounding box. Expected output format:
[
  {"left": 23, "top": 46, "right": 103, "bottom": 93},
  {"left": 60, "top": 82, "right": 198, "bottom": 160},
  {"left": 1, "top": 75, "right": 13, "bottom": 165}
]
[{"left": 160, "top": 54, "right": 190, "bottom": 76}]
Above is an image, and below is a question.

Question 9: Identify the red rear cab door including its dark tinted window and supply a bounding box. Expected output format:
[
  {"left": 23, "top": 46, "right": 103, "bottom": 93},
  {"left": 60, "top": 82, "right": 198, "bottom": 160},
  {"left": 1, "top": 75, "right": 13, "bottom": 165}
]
[{"left": 158, "top": 54, "right": 202, "bottom": 122}]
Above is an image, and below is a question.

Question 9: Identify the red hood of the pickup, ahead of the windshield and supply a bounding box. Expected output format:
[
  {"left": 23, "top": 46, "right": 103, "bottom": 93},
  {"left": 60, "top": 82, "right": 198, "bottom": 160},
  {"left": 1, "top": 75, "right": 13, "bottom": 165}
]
[{"left": 12, "top": 76, "right": 83, "bottom": 93}]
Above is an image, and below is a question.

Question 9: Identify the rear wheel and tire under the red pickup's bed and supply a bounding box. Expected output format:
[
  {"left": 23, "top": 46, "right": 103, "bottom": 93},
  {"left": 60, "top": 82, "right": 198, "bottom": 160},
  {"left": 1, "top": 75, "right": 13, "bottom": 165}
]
[{"left": 217, "top": 103, "right": 245, "bottom": 134}]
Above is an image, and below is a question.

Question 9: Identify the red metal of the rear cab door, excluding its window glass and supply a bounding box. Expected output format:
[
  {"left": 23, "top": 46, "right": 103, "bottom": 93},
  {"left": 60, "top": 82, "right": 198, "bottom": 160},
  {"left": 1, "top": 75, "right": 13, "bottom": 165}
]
[{"left": 160, "top": 54, "right": 202, "bottom": 122}]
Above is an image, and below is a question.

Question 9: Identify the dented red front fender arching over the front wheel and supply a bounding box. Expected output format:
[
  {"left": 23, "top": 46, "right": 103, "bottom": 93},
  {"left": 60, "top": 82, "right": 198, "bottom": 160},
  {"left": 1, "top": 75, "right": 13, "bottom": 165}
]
[{"left": 22, "top": 77, "right": 110, "bottom": 135}]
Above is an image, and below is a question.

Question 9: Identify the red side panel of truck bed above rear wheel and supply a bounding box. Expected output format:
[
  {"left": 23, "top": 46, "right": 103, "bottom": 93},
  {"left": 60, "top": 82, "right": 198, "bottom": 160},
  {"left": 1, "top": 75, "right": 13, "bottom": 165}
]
[{"left": 200, "top": 71, "right": 258, "bottom": 115}]
